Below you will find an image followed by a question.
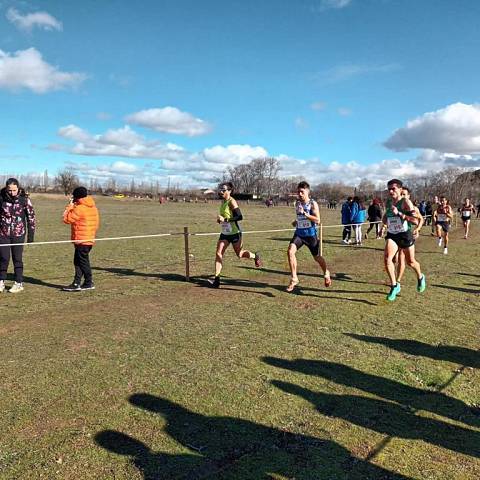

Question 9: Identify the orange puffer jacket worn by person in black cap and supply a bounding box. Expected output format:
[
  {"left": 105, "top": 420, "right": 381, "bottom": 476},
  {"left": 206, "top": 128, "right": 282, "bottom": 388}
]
[{"left": 63, "top": 196, "right": 100, "bottom": 245}]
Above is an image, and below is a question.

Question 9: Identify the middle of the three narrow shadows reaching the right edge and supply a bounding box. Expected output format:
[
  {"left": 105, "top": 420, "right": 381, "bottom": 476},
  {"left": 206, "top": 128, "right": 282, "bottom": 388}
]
[{"left": 262, "top": 357, "right": 480, "bottom": 427}]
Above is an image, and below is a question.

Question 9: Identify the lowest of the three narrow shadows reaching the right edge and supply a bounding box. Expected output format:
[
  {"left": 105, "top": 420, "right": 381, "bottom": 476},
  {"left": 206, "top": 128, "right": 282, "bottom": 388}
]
[{"left": 272, "top": 380, "right": 480, "bottom": 457}]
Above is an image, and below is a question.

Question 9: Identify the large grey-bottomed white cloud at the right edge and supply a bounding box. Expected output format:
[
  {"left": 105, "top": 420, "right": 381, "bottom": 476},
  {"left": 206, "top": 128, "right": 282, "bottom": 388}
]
[{"left": 384, "top": 103, "right": 480, "bottom": 155}]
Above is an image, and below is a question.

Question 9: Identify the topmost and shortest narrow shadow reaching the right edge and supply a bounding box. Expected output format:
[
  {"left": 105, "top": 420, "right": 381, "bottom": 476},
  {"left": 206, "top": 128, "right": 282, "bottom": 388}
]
[{"left": 345, "top": 333, "right": 480, "bottom": 368}]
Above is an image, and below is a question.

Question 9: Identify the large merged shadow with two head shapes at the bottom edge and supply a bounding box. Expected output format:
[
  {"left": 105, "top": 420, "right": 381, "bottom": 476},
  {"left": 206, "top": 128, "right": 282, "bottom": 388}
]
[{"left": 95, "top": 393, "right": 408, "bottom": 480}]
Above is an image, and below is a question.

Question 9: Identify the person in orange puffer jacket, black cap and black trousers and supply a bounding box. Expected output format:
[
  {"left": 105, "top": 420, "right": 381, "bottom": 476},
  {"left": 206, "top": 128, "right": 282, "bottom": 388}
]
[{"left": 62, "top": 187, "right": 100, "bottom": 292}]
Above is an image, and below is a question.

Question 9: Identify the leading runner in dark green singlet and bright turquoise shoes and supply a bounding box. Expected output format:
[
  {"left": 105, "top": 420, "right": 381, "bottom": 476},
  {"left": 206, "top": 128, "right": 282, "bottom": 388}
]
[{"left": 383, "top": 179, "right": 426, "bottom": 302}]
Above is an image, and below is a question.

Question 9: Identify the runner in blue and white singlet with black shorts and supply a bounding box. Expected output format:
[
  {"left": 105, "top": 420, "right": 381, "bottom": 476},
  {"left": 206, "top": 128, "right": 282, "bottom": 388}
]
[{"left": 287, "top": 182, "right": 332, "bottom": 292}]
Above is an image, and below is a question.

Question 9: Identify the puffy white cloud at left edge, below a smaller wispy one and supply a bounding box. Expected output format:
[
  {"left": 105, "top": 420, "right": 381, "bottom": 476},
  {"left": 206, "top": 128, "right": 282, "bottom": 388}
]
[{"left": 0, "top": 48, "right": 87, "bottom": 93}]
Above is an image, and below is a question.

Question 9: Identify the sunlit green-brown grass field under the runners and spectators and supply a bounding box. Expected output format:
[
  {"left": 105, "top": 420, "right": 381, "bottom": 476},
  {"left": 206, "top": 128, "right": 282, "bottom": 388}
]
[{"left": 0, "top": 196, "right": 480, "bottom": 480}]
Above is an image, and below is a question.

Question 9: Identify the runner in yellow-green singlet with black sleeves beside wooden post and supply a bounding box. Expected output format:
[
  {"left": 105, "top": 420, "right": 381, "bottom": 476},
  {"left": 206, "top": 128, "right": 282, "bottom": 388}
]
[{"left": 209, "top": 182, "right": 262, "bottom": 288}]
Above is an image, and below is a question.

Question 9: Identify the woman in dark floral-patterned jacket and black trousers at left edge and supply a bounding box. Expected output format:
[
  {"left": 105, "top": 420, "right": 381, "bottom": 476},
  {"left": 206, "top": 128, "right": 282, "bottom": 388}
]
[{"left": 0, "top": 178, "right": 35, "bottom": 293}]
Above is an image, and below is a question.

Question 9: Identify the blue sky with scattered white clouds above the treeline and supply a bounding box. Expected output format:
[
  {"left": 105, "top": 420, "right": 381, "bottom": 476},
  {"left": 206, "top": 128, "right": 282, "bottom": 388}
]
[{"left": 0, "top": 0, "right": 480, "bottom": 187}]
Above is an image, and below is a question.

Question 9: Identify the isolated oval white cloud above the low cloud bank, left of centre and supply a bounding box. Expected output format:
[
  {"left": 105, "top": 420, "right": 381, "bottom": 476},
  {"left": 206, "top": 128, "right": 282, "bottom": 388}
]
[{"left": 125, "top": 107, "right": 212, "bottom": 137}]
